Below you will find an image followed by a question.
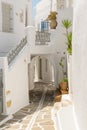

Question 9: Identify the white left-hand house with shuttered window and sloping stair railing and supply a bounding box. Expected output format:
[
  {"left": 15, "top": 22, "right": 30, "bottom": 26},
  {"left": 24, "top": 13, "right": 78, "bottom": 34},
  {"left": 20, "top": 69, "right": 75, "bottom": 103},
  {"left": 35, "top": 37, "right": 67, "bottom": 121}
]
[{"left": 0, "top": 0, "right": 31, "bottom": 115}]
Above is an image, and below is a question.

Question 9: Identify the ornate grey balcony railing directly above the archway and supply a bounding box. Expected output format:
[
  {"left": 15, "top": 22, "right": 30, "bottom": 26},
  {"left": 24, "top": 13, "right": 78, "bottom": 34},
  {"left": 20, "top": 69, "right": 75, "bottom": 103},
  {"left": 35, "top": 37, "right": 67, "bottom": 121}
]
[{"left": 35, "top": 31, "right": 50, "bottom": 45}]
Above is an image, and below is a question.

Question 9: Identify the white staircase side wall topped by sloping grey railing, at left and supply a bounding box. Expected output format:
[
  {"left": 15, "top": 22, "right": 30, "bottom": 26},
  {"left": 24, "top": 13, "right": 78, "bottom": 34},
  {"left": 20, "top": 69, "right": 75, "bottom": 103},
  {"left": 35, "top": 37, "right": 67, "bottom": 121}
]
[{"left": 0, "top": 37, "right": 29, "bottom": 118}]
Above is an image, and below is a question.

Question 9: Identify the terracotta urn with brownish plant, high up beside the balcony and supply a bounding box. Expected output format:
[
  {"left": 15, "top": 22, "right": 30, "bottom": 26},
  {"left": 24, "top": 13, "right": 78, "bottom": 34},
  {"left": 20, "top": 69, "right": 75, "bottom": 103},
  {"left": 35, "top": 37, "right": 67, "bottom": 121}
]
[{"left": 47, "top": 11, "right": 57, "bottom": 29}]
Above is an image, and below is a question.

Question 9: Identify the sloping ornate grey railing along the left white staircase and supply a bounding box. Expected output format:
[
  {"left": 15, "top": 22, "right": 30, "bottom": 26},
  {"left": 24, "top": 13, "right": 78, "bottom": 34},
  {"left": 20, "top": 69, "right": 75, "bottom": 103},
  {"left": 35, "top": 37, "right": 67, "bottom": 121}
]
[{"left": 7, "top": 37, "right": 27, "bottom": 65}]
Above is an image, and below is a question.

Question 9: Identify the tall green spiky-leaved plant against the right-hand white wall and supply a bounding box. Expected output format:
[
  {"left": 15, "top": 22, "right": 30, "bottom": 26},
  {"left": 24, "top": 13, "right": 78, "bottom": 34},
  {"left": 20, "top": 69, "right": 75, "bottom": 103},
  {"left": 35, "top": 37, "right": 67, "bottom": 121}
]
[{"left": 62, "top": 19, "right": 72, "bottom": 54}]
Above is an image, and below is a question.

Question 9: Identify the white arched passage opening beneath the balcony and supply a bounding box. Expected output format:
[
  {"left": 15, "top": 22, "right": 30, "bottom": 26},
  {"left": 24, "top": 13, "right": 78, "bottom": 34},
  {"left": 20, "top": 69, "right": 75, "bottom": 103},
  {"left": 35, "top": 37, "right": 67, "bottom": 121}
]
[{"left": 29, "top": 55, "right": 55, "bottom": 90}]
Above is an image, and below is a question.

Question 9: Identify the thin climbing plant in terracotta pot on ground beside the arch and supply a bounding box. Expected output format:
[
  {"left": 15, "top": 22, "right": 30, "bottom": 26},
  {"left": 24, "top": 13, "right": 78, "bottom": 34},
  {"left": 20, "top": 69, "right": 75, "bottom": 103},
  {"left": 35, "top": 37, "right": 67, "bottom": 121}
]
[{"left": 59, "top": 52, "right": 68, "bottom": 93}]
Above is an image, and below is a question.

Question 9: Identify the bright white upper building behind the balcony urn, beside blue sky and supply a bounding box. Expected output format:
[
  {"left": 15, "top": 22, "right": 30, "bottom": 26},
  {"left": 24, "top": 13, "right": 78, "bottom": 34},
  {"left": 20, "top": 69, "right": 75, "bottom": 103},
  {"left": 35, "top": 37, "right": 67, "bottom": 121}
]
[{"left": 35, "top": 0, "right": 73, "bottom": 28}]
